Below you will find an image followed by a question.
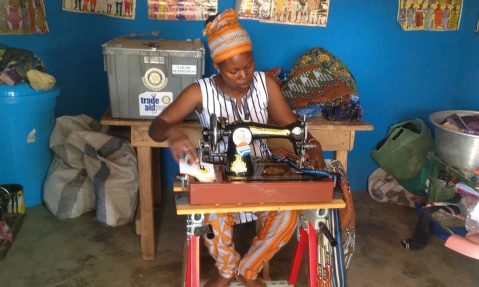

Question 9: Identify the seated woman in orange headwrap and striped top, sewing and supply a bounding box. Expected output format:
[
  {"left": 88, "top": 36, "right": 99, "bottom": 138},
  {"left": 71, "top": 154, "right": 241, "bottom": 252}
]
[{"left": 150, "top": 9, "right": 324, "bottom": 287}]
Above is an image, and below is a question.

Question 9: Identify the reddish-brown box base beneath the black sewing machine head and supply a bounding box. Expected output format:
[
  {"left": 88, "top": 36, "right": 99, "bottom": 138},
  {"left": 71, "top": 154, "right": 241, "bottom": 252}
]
[{"left": 189, "top": 163, "right": 334, "bottom": 204}]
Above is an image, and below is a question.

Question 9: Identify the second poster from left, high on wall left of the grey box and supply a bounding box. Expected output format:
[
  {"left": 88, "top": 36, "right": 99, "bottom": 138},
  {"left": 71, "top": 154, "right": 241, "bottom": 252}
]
[{"left": 63, "top": 0, "right": 136, "bottom": 20}]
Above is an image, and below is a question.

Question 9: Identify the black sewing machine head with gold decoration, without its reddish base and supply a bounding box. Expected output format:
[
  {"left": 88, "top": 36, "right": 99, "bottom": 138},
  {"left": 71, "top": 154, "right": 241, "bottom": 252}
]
[{"left": 200, "top": 114, "right": 314, "bottom": 181}]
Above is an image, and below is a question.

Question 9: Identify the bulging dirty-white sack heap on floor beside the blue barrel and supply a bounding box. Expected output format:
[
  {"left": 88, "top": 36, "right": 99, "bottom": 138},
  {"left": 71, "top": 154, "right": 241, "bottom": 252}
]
[{"left": 44, "top": 115, "right": 138, "bottom": 226}]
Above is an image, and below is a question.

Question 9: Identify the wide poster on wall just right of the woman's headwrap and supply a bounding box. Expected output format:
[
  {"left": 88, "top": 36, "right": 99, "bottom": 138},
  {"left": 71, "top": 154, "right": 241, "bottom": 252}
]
[{"left": 236, "top": 0, "right": 329, "bottom": 27}]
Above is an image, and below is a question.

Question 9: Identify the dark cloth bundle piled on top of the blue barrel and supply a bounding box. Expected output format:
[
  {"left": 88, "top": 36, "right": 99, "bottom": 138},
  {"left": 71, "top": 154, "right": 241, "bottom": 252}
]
[{"left": 0, "top": 44, "right": 56, "bottom": 90}]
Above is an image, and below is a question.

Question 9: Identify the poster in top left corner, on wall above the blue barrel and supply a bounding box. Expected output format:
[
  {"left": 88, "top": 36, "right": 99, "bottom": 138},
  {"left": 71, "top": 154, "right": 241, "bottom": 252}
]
[{"left": 0, "top": 0, "right": 48, "bottom": 35}]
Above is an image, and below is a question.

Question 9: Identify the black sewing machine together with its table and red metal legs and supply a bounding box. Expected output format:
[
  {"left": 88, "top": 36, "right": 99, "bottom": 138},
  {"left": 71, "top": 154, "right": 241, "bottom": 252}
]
[{"left": 175, "top": 117, "right": 345, "bottom": 287}]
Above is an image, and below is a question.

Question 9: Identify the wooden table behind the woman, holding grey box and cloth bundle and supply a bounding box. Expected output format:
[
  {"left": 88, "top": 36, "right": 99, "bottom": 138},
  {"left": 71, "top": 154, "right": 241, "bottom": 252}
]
[{"left": 100, "top": 112, "right": 373, "bottom": 260}]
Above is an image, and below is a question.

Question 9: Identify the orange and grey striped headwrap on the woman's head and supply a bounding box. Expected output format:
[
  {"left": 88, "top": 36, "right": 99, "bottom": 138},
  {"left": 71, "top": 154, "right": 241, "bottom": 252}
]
[{"left": 203, "top": 9, "right": 252, "bottom": 64}]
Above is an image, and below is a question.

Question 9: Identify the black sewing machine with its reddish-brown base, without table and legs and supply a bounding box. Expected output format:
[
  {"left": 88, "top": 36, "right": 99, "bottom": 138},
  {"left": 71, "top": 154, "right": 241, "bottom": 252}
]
[{"left": 180, "top": 114, "right": 334, "bottom": 204}]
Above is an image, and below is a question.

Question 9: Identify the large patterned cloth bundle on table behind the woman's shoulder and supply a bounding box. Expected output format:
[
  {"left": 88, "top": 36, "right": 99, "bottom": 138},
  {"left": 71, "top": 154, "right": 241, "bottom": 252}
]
[{"left": 281, "top": 47, "right": 364, "bottom": 121}]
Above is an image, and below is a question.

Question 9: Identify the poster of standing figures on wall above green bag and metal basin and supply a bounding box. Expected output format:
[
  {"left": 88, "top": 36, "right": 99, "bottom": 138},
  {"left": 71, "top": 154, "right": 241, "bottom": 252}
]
[{"left": 398, "top": 0, "right": 463, "bottom": 31}]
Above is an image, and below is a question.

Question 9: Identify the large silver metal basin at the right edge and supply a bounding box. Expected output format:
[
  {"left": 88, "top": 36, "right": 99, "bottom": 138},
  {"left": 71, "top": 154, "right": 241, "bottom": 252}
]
[{"left": 429, "top": 110, "right": 479, "bottom": 171}]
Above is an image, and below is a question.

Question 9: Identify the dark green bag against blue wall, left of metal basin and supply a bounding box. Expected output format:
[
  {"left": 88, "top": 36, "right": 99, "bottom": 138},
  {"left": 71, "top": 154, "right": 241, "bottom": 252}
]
[{"left": 371, "top": 118, "right": 434, "bottom": 180}]
